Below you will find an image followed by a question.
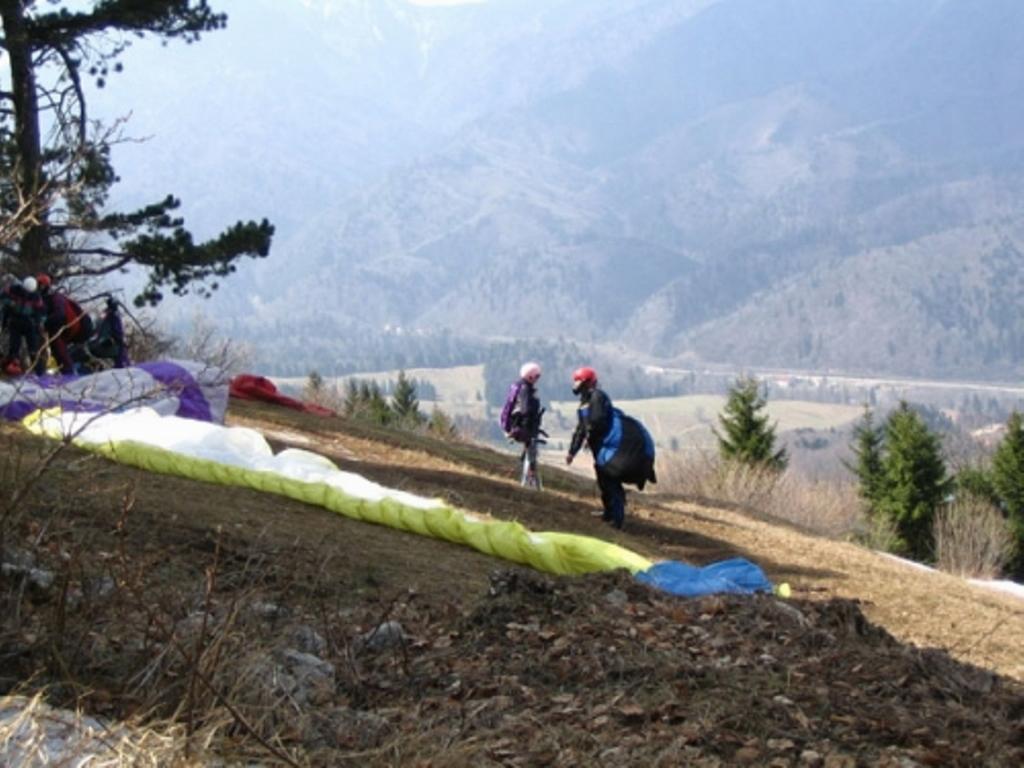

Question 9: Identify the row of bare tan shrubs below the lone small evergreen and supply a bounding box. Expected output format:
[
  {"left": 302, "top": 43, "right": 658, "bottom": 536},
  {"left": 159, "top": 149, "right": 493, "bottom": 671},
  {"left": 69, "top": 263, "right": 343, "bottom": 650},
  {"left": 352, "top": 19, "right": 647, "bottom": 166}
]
[{"left": 658, "top": 452, "right": 863, "bottom": 537}]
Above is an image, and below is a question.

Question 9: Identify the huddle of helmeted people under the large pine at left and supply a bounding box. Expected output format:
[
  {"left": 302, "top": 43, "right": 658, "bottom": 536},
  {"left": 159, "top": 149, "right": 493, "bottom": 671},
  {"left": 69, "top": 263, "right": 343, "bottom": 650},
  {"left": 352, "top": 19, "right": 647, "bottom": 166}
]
[{"left": 0, "top": 272, "right": 128, "bottom": 376}]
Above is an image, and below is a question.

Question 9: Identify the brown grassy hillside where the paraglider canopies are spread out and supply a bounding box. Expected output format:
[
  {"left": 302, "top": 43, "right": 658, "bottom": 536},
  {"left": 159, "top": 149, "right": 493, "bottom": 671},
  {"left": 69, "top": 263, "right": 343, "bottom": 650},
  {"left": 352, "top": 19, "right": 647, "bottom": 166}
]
[{"left": 0, "top": 400, "right": 1024, "bottom": 766}]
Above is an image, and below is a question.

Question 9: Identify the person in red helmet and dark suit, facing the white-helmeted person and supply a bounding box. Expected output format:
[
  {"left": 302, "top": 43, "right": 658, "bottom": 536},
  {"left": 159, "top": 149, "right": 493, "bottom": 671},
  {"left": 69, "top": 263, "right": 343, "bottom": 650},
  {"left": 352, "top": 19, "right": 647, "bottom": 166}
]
[{"left": 565, "top": 366, "right": 626, "bottom": 529}]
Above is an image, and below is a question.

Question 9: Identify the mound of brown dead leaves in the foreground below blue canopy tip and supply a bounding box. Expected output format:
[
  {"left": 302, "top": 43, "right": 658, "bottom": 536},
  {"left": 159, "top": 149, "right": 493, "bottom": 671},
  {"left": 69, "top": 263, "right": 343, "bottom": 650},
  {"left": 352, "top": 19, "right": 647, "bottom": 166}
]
[{"left": 329, "top": 571, "right": 1024, "bottom": 768}]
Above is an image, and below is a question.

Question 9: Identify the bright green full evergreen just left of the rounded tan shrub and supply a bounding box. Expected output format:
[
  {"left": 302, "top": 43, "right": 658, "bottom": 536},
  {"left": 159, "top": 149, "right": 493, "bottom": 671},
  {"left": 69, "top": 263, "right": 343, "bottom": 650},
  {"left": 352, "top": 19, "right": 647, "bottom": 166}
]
[{"left": 879, "top": 402, "right": 951, "bottom": 561}]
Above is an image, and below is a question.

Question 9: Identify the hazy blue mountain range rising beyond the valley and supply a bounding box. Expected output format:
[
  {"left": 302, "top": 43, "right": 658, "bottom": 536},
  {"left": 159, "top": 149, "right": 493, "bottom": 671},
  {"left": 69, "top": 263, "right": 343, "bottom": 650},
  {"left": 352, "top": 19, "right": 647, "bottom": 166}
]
[{"left": 100, "top": 0, "right": 1024, "bottom": 379}]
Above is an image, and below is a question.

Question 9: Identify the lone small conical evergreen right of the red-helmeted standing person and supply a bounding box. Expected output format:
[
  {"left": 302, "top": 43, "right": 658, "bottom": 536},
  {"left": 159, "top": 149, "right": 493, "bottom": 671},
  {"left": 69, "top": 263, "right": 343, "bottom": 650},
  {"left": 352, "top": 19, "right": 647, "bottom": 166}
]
[{"left": 714, "top": 377, "right": 788, "bottom": 471}]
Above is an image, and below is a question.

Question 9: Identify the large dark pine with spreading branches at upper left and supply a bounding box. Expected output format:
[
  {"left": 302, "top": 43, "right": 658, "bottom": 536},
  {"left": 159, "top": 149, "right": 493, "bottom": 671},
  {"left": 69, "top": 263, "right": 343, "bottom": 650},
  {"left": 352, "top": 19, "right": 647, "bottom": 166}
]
[{"left": 0, "top": 0, "right": 273, "bottom": 305}]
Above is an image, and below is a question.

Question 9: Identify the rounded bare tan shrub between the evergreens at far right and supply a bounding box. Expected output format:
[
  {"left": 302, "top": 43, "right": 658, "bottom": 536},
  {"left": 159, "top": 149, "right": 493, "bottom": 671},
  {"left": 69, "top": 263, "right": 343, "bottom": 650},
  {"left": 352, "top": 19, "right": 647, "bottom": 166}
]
[{"left": 932, "top": 496, "right": 1015, "bottom": 579}]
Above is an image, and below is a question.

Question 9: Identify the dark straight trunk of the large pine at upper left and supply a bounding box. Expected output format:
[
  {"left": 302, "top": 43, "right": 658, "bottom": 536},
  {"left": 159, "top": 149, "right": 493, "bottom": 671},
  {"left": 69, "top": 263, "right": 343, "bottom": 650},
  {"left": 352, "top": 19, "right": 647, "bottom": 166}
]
[{"left": 0, "top": 0, "right": 49, "bottom": 274}]
